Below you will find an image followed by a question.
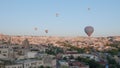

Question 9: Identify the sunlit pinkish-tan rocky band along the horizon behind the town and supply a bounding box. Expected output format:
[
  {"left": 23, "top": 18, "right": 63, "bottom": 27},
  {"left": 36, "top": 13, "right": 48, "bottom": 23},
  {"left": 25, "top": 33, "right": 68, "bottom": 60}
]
[{"left": 0, "top": 34, "right": 120, "bottom": 45}]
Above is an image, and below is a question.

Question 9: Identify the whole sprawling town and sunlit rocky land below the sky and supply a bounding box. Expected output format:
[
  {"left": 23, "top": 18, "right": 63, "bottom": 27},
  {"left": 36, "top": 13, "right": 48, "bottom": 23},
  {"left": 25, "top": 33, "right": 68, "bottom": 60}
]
[{"left": 0, "top": 34, "right": 120, "bottom": 68}]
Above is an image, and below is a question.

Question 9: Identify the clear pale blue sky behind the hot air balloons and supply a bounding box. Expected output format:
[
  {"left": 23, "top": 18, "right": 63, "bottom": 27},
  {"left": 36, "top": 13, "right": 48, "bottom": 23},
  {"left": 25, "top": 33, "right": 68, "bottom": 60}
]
[{"left": 0, "top": 0, "right": 120, "bottom": 36}]
